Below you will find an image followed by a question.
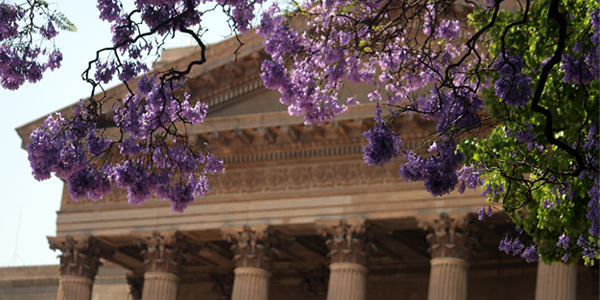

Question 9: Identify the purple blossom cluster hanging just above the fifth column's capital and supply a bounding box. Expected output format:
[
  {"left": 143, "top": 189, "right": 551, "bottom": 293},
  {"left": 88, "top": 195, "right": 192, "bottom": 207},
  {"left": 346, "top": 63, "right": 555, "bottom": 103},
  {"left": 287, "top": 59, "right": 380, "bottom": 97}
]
[{"left": 400, "top": 141, "right": 465, "bottom": 196}]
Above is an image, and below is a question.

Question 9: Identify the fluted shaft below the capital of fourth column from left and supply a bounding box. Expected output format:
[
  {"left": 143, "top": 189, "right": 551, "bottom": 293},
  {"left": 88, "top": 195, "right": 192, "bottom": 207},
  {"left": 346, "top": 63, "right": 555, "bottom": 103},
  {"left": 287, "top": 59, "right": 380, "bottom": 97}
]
[{"left": 327, "top": 262, "right": 368, "bottom": 300}]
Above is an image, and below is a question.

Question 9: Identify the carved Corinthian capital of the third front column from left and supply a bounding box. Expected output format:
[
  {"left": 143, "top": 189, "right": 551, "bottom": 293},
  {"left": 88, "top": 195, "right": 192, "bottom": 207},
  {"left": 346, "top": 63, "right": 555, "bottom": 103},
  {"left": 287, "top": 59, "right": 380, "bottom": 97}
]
[{"left": 223, "top": 225, "right": 279, "bottom": 270}]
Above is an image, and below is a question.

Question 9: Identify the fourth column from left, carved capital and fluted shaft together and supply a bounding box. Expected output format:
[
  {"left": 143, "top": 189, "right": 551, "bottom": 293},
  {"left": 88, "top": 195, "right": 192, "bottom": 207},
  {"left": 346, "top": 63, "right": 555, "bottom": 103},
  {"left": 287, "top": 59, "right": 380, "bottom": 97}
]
[{"left": 317, "top": 220, "right": 374, "bottom": 300}]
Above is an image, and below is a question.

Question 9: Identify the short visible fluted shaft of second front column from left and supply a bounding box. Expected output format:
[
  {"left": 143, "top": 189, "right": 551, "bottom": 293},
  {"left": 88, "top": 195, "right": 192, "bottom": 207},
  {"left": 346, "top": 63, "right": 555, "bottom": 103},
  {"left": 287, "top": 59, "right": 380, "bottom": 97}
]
[{"left": 142, "top": 271, "right": 179, "bottom": 300}]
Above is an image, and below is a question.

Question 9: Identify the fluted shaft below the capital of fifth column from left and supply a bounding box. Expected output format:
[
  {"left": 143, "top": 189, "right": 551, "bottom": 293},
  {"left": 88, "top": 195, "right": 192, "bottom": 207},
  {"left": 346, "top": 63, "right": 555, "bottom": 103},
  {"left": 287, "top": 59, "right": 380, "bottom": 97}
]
[{"left": 427, "top": 257, "right": 469, "bottom": 300}]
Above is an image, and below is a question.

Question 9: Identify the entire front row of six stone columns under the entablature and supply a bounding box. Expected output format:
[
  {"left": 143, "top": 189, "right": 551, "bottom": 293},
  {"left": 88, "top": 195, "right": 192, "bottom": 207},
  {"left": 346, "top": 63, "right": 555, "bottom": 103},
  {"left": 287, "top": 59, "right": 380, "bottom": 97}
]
[{"left": 50, "top": 214, "right": 576, "bottom": 300}]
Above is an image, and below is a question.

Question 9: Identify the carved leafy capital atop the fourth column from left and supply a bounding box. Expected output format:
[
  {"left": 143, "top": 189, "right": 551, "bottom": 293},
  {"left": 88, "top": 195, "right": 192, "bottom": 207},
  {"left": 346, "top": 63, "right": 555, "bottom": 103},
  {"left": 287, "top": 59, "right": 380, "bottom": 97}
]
[{"left": 317, "top": 220, "right": 375, "bottom": 266}]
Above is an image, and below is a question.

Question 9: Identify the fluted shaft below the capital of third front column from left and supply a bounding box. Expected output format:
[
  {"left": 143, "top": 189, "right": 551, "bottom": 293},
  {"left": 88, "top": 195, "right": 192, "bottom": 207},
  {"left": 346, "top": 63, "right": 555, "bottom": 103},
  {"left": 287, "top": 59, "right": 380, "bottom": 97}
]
[{"left": 231, "top": 267, "right": 271, "bottom": 300}]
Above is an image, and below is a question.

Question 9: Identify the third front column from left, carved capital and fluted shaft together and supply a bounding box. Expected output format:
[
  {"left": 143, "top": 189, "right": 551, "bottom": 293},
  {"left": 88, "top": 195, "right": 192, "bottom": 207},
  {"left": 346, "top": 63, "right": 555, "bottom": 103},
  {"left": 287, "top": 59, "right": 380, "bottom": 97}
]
[{"left": 223, "top": 226, "right": 279, "bottom": 300}]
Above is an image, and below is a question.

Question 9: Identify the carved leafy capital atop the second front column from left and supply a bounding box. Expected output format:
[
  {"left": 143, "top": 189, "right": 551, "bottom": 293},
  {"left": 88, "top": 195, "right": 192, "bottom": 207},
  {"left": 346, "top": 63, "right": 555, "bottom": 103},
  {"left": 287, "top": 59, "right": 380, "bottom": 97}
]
[{"left": 133, "top": 231, "right": 200, "bottom": 275}]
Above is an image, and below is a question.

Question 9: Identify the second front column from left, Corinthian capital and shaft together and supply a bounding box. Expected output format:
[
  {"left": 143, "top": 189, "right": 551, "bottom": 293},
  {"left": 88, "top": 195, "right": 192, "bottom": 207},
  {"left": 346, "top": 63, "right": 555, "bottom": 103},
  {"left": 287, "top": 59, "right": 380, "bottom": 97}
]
[{"left": 134, "top": 231, "right": 196, "bottom": 300}]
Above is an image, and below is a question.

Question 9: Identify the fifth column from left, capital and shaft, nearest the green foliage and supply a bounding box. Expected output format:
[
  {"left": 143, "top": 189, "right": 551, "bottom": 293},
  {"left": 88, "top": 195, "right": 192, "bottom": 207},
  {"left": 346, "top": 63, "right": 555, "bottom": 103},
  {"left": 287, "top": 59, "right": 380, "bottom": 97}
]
[{"left": 419, "top": 214, "right": 474, "bottom": 300}]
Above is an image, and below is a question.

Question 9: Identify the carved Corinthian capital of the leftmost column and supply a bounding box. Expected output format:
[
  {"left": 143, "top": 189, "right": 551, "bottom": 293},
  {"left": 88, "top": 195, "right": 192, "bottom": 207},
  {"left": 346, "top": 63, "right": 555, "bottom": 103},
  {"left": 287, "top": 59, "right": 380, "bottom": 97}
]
[{"left": 48, "top": 235, "right": 111, "bottom": 280}]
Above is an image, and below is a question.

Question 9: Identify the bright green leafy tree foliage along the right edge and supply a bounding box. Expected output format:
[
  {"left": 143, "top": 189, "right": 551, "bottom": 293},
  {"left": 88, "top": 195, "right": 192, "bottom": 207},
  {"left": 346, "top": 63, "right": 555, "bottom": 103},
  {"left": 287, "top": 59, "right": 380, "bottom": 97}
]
[{"left": 459, "top": 0, "right": 600, "bottom": 263}]
